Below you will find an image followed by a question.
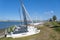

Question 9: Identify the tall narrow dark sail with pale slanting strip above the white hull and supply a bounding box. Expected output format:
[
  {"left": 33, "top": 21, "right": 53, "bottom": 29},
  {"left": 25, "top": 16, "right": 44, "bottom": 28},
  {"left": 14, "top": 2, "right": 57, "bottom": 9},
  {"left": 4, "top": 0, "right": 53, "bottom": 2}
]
[{"left": 20, "top": 0, "right": 33, "bottom": 25}]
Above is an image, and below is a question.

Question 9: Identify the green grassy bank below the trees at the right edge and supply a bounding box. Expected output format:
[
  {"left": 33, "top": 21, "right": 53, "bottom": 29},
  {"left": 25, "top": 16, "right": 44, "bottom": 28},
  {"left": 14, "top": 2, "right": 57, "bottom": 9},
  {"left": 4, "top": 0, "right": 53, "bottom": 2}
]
[{"left": 45, "top": 21, "right": 60, "bottom": 33}]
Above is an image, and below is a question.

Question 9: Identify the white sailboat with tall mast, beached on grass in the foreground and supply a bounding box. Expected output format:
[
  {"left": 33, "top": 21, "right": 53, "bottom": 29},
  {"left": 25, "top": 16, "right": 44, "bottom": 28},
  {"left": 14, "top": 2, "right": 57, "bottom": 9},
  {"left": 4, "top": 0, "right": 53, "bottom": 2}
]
[{"left": 6, "top": 1, "right": 40, "bottom": 38}]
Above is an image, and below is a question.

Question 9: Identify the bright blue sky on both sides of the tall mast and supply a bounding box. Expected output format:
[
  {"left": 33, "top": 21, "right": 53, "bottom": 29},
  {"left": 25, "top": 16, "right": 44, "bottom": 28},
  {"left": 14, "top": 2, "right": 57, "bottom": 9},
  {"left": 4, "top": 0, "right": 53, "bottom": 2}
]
[{"left": 0, "top": 0, "right": 60, "bottom": 20}]
